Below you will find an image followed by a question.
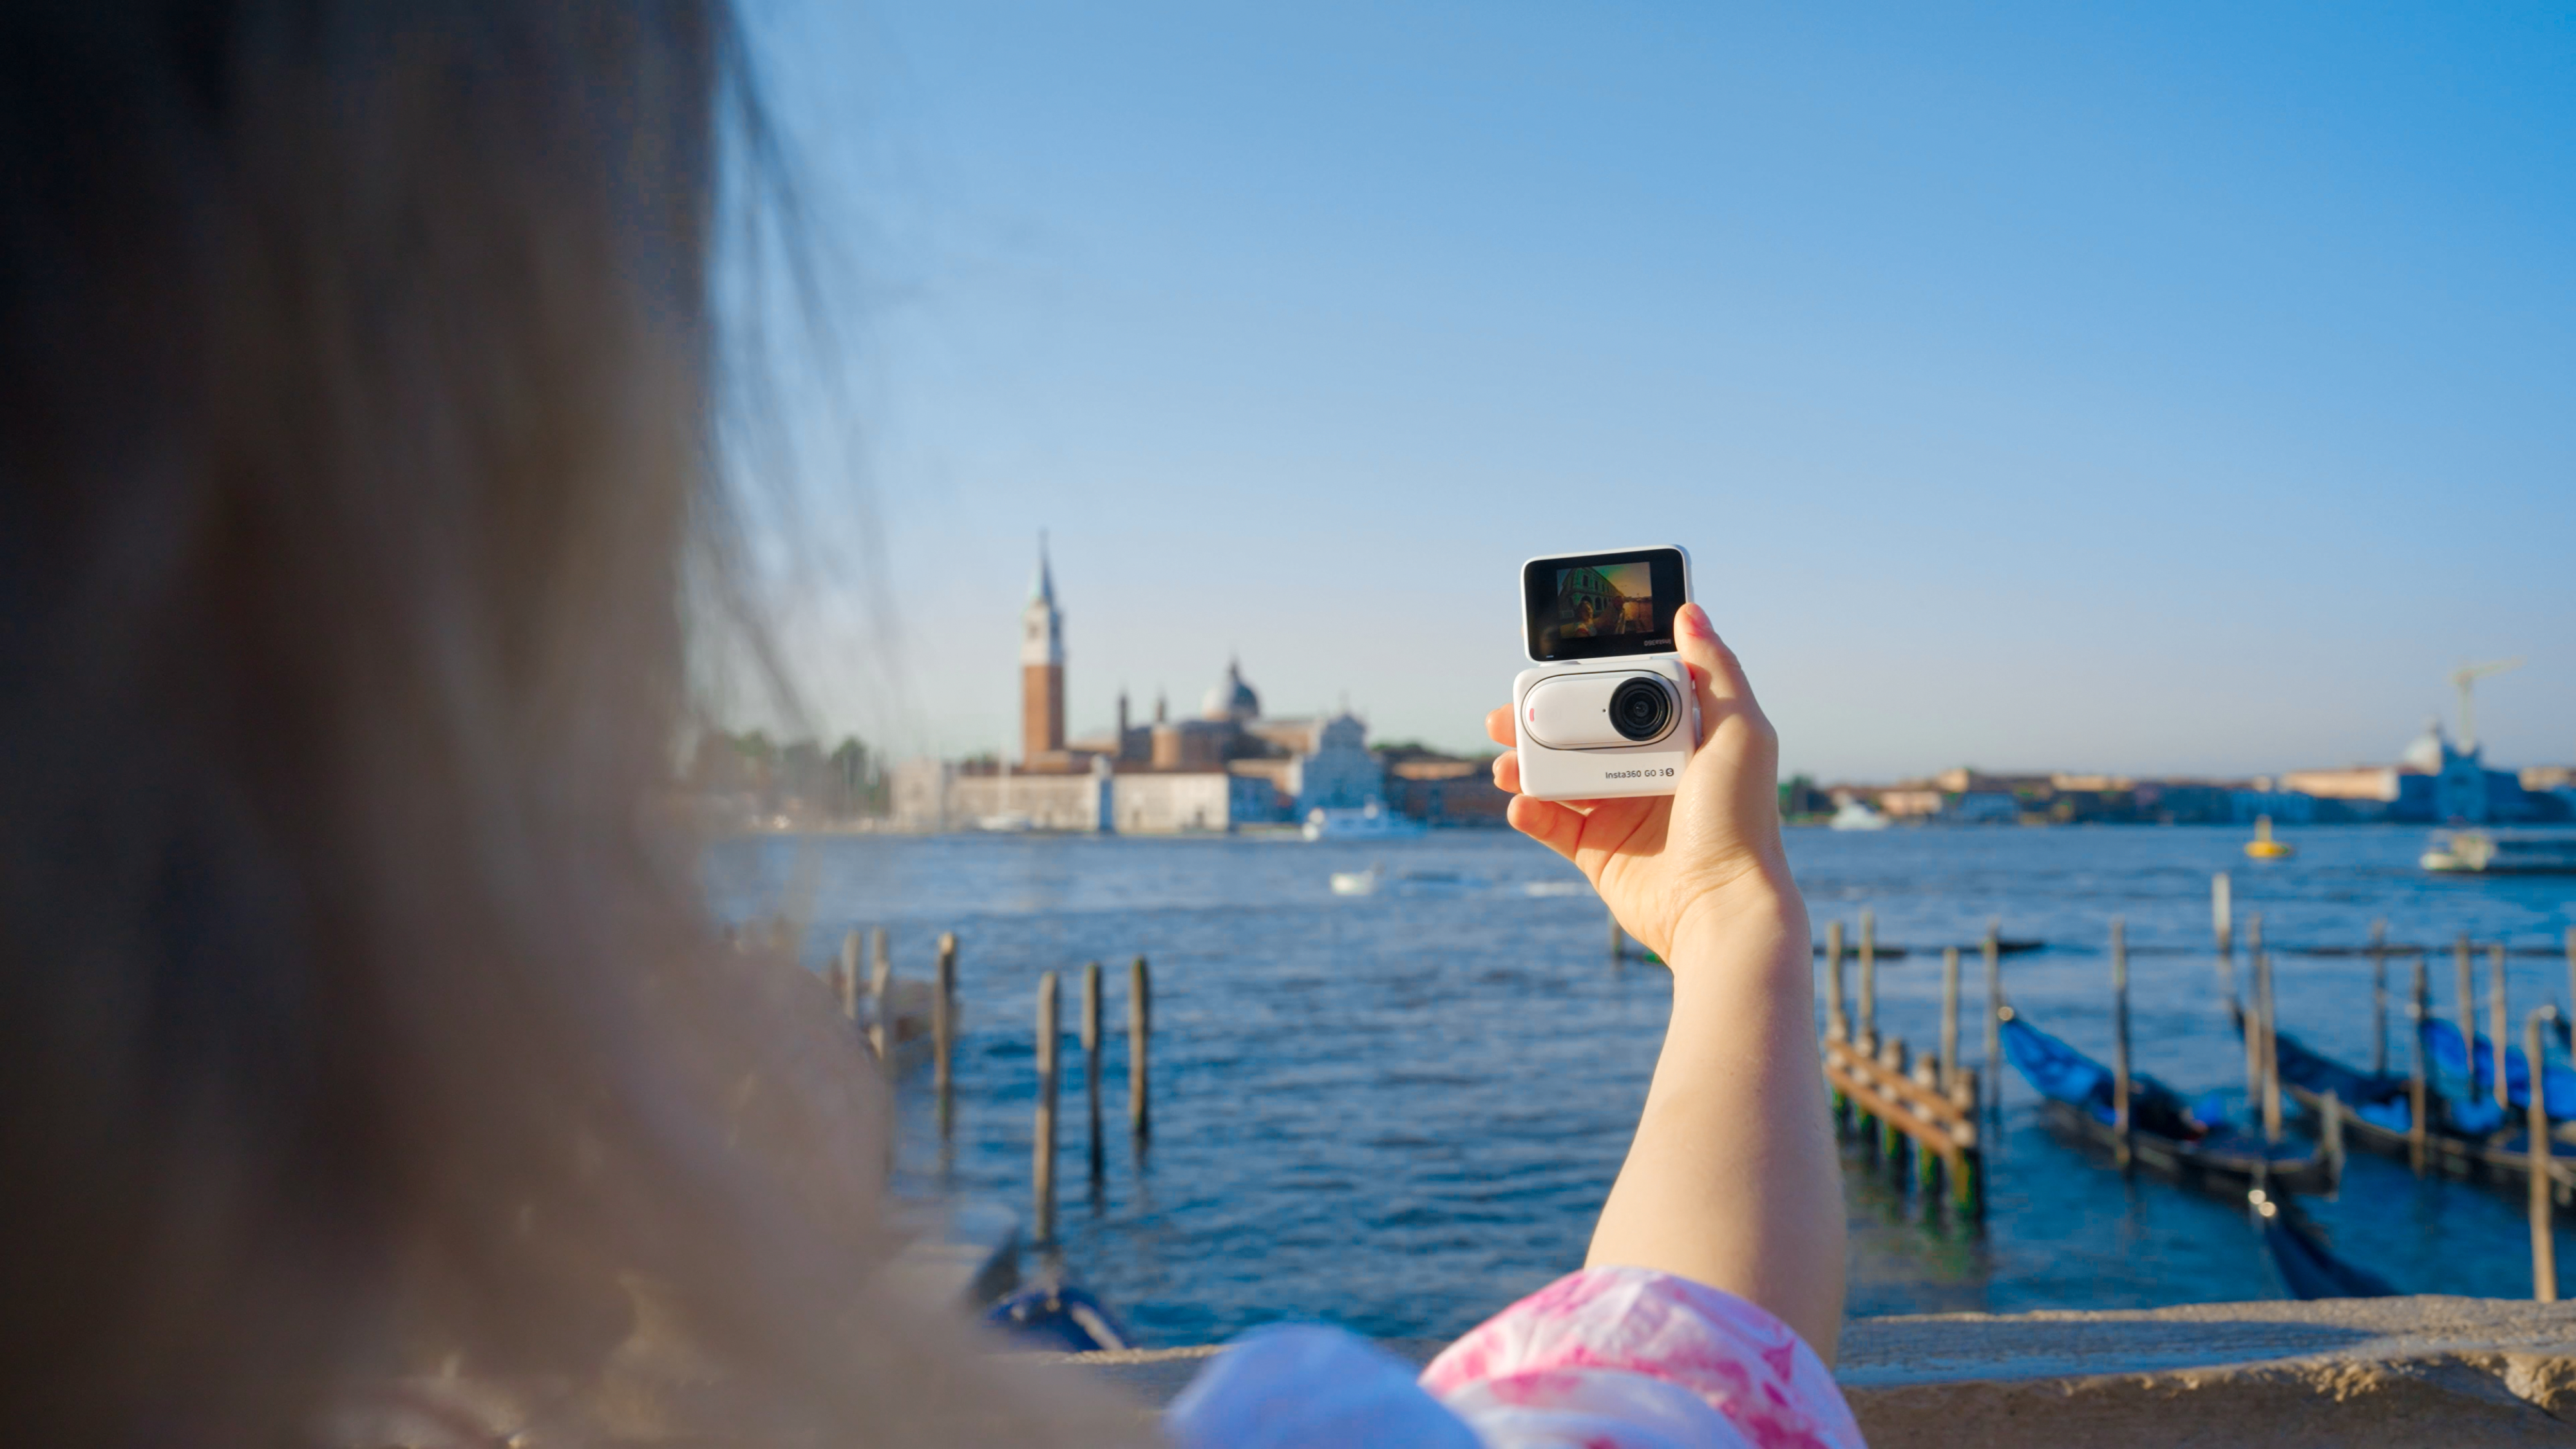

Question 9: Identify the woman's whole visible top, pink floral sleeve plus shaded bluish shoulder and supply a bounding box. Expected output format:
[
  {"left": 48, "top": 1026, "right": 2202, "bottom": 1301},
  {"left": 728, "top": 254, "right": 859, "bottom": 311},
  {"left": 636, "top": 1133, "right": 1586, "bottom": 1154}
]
[{"left": 1164, "top": 1269, "right": 1862, "bottom": 1449}]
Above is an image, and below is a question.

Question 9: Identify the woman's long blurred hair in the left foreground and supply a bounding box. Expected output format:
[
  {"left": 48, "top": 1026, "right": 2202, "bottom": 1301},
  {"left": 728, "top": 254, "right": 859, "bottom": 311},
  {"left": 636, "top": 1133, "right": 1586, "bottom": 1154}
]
[{"left": 0, "top": 0, "right": 1133, "bottom": 1444}]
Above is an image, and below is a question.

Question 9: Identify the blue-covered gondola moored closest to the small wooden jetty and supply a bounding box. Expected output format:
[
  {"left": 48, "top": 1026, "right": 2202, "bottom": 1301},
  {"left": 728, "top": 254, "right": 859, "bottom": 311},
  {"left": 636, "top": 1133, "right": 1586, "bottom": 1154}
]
[{"left": 1999, "top": 1005, "right": 2342, "bottom": 1197}]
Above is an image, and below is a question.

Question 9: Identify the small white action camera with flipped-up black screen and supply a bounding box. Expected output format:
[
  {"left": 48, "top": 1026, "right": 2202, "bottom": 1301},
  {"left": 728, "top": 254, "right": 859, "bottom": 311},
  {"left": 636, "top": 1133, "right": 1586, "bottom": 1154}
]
[{"left": 1512, "top": 547, "right": 1700, "bottom": 799}]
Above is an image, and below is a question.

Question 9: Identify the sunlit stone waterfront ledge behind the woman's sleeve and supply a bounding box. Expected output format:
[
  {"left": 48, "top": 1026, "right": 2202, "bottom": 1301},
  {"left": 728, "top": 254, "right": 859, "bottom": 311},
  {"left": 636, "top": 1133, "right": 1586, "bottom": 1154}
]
[{"left": 1056, "top": 1297, "right": 2576, "bottom": 1449}]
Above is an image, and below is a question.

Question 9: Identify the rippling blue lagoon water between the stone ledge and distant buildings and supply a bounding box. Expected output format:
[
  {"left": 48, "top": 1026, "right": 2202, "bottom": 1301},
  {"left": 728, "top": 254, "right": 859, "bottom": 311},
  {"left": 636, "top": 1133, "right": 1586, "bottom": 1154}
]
[{"left": 708, "top": 828, "right": 2576, "bottom": 1343}]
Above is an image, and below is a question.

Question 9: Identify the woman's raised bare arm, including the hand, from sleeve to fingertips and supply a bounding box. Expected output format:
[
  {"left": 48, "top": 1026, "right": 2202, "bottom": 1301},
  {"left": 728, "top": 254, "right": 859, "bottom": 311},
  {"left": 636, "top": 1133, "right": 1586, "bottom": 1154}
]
[{"left": 1486, "top": 603, "right": 1844, "bottom": 1364}]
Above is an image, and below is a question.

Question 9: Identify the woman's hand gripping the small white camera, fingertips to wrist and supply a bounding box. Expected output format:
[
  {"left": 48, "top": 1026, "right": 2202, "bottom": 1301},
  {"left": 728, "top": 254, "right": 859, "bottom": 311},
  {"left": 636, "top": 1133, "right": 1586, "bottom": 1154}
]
[{"left": 1484, "top": 603, "right": 1795, "bottom": 961}]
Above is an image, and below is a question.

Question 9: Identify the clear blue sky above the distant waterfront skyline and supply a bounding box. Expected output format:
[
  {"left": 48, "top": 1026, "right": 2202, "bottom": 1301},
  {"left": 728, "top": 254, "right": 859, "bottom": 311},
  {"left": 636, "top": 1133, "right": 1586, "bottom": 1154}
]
[{"left": 752, "top": 0, "right": 2576, "bottom": 779}]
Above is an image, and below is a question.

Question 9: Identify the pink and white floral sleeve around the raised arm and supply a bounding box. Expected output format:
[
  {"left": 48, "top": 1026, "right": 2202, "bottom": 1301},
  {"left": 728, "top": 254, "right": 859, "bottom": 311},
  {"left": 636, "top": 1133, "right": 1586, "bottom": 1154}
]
[{"left": 1422, "top": 1269, "right": 1862, "bottom": 1449}]
